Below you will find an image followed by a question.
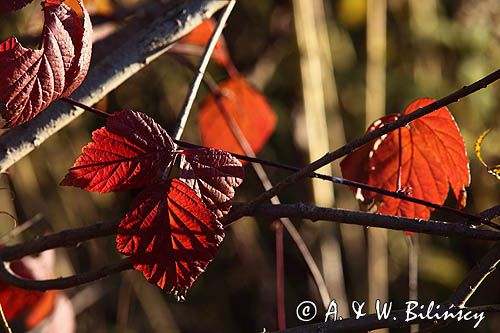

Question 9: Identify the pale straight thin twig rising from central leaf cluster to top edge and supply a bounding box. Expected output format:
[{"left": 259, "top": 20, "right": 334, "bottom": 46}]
[{"left": 173, "top": 0, "right": 236, "bottom": 140}]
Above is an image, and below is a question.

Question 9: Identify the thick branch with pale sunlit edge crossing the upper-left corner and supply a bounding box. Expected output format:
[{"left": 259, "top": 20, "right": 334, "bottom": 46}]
[{"left": 0, "top": 0, "right": 228, "bottom": 172}]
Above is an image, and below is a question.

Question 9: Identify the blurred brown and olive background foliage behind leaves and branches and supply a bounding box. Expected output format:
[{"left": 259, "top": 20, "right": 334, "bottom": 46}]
[{"left": 0, "top": 0, "right": 500, "bottom": 332}]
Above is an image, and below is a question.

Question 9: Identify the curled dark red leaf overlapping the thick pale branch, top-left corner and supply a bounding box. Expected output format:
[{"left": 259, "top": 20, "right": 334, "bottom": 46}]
[{"left": 0, "top": 0, "right": 92, "bottom": 128}]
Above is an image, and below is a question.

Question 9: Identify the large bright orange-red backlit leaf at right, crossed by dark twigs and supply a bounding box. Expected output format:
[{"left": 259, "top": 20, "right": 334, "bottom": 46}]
[{"left": 340, "top": 98, "right": 470, "bottom": 219}]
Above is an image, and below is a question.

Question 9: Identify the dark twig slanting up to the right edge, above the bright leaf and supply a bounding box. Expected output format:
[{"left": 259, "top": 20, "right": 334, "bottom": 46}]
[{"left": 226, "top": 69, "right": 500, "bottom": 220}]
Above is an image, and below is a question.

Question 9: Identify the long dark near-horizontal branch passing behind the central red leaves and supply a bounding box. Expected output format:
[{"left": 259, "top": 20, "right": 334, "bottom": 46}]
[{"left": 0, "top": 203, "right": 500, "bottom": 261}]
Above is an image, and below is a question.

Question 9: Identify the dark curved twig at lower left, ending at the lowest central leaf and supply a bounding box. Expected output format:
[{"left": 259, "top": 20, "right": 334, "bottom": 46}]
[{"left": 0, "top": 258, "right": 133, "bottom": 291}]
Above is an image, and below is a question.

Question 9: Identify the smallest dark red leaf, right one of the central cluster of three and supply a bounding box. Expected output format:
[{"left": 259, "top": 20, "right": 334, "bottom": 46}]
[{"left": 179, "top": 148, "right": 244, "bottom": 218}]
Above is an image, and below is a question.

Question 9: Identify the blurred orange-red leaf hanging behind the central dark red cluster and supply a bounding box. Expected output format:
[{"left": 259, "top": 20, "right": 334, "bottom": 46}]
[{"left": 199, "top": 77, "right": 276, "bottom": 154}]
